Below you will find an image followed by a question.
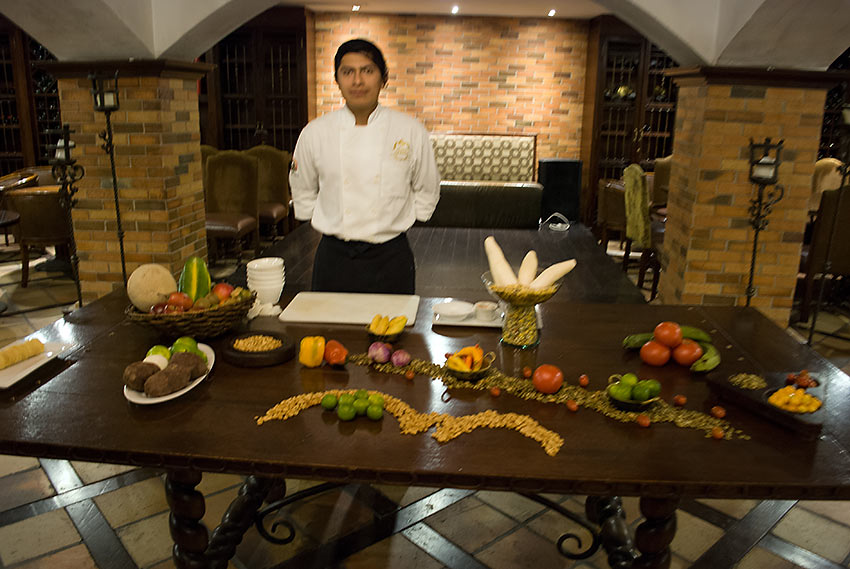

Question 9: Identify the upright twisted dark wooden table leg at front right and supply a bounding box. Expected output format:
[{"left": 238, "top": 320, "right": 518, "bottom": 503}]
[{"left": 632, "top": 498, "right": 679, "bottom": 569}]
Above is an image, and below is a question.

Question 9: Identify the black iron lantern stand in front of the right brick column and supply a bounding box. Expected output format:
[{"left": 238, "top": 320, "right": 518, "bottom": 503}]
[{"left": 747, "top": 138, "right": 785, "bottom": 306}]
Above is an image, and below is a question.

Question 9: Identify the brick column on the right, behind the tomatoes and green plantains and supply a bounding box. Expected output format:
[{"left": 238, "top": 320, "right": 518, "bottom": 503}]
[{"left": 660, "top": 68, "right": 836, "bottom": 326}]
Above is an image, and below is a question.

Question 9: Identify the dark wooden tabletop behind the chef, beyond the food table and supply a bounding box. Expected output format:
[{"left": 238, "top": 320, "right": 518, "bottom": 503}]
[{"left": 228, "top": 223, "right": 645, "bottom": 303}]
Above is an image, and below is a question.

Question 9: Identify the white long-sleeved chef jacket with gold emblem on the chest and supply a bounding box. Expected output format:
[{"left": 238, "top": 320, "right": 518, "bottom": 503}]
[{"left": 289, "top": 105, "right": 440, "bottom": 243}]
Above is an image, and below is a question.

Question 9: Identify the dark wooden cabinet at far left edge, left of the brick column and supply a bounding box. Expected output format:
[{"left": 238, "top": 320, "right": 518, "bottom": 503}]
[{"left": 0, "top": 16, "right": 61, "bottom": 175}]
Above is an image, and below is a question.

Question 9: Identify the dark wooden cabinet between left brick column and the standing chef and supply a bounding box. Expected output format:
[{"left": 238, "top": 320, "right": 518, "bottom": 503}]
[{"left": 200, "top": 7, "right": 307, "bottom": 152}]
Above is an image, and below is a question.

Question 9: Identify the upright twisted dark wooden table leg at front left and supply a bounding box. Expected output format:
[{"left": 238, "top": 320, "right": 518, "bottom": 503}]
[{"left": 165, "top": 470, "right": 207, "bottom": 569}]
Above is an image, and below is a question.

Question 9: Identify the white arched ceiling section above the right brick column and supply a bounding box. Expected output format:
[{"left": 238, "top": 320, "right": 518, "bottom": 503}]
[{"left": 596, "top": 0, "right": 850, "bottom": 70}]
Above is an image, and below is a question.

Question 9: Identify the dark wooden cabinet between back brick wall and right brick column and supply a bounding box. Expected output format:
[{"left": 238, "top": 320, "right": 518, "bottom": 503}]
[{"left": 582, "top": 16, "right": 676, "bottom": 224}]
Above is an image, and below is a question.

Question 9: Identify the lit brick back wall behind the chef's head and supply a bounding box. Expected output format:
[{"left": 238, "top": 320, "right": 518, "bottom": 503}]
[{"left": 311, "top": 13, "right": 588, "bottom": 162}]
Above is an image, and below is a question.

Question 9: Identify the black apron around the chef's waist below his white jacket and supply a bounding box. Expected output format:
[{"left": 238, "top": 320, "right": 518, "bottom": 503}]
[{"left": 312, "top": 233, "right": 416, "bottom": 294}]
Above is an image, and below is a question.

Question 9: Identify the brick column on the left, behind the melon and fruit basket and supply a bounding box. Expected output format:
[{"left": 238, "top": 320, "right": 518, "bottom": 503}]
[{"left": 46, "top": 60, "right": 210, "bottom": 301}]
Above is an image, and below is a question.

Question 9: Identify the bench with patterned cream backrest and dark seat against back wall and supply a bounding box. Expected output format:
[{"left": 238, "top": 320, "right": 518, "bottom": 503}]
[{"left": 425, "top": 133, "right": 543, "bottom": 229}]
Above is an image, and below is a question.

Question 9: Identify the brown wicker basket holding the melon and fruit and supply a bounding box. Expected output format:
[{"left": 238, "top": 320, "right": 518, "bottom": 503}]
[{"left": 124, "top": 293, "right": 257, "bottom": 338}]
